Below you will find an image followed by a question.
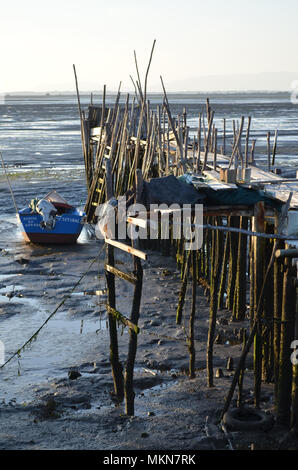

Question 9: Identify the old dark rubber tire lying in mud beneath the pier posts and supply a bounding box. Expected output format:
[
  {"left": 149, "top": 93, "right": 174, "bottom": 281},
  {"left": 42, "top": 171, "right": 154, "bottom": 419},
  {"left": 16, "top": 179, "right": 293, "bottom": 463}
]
[{"left": 223, "top": 407, "right": 274, "bottom": 431}]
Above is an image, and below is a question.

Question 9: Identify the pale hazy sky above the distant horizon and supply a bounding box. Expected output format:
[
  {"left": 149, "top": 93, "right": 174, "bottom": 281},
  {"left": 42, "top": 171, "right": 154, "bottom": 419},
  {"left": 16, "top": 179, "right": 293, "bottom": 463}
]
[{"left": 0, "top": 0, "right": 298, "bottom": 92}]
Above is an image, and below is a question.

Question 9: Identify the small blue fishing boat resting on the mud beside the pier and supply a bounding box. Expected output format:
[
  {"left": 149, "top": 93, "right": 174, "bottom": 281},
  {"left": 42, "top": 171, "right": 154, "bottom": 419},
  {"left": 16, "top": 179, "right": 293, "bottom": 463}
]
[{"left": 17, "top": 191, "right": 86, "bottom": 244}]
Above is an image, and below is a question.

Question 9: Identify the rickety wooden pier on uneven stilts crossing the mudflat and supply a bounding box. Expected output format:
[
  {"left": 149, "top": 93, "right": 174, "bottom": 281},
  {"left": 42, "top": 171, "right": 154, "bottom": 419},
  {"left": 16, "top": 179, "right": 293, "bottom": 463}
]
[{"left": 74, "top": 68, "right": 298, "bottom": 430}]
